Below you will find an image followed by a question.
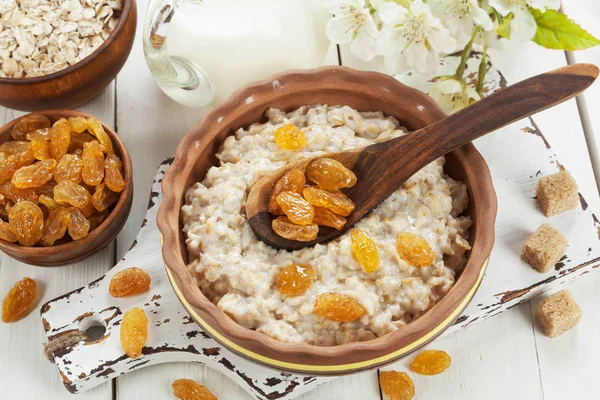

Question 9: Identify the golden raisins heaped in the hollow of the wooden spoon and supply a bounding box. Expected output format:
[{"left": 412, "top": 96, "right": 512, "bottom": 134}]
[{"left": 268, "top": 156, "right": 356, "bottom": 242}]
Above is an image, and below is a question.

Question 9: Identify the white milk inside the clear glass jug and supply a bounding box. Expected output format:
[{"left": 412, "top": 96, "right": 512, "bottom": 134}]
[{"left": 166, "top": 0, "right": 330, "bottom": 104}]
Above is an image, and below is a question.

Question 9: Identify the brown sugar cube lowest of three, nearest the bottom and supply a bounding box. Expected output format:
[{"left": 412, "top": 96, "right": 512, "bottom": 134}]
[{"left": 535, "top": 290, "right": 583, "bottom": 337}]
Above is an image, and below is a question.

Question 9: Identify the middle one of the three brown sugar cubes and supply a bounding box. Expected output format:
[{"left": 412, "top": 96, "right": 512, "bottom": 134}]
[{"left": 521, "top": 224, "right": 568, "bottom": 273}]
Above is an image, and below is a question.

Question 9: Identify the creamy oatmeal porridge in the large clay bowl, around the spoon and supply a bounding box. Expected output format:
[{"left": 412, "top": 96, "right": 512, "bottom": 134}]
[{"left": 182, "top": 105, "right": 472, "bottom": 346}]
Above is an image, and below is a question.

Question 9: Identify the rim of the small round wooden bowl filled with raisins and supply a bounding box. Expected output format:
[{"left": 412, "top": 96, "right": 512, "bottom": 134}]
[{"left": 0, "top": 109, "right": 133, "bottom": 260}]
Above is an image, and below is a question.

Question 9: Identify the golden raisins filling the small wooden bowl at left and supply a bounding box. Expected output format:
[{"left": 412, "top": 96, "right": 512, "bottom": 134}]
[{"left": 0, "top": 114, "right": 125, "bottom": 246}]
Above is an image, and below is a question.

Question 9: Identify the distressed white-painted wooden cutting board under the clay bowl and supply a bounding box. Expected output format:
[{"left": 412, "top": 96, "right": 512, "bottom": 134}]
[{"left": 41, "top": 55, "right": 600, "bottom": 399}]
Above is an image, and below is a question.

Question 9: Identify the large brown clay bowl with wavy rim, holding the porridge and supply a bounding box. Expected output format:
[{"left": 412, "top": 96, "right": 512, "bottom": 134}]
[{"left": 157, "top": 67, "right": 496, "bottom": 374}]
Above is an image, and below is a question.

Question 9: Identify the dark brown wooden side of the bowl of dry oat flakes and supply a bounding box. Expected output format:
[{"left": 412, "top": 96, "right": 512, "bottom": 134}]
[{"left": 0, "top": 0, "right": 137, "bottom": 111}]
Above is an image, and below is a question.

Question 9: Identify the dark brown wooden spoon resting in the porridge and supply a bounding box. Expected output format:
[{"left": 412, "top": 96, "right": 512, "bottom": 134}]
[{"left": 246, "top": 64, "right": 598, "bottom": 250}]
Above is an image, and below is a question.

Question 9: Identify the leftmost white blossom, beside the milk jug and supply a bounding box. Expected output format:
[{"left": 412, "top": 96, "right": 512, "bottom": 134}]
[{"left": 324, "top": 0, "right": 378, "bottom": 61}]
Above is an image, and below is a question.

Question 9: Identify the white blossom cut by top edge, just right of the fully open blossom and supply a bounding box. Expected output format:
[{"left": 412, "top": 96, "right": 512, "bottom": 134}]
[{"left": 427, "top": 0, "right": 494, "bottom": 44}]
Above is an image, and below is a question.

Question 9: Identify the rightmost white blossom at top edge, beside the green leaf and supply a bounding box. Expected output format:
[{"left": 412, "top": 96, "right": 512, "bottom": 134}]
[{"left": 489, "top": 0, "right": 560, "bottom": 41}]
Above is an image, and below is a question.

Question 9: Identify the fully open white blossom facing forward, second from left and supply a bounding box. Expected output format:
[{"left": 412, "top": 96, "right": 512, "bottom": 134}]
[{"left": 377, "top": 0, "right": 456, "bottom": 73}]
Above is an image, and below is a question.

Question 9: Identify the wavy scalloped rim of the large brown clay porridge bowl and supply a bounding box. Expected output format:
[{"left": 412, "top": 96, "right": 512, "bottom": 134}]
[{"left": 157, "top": 66, "right": 497, "bottom": 374}]
